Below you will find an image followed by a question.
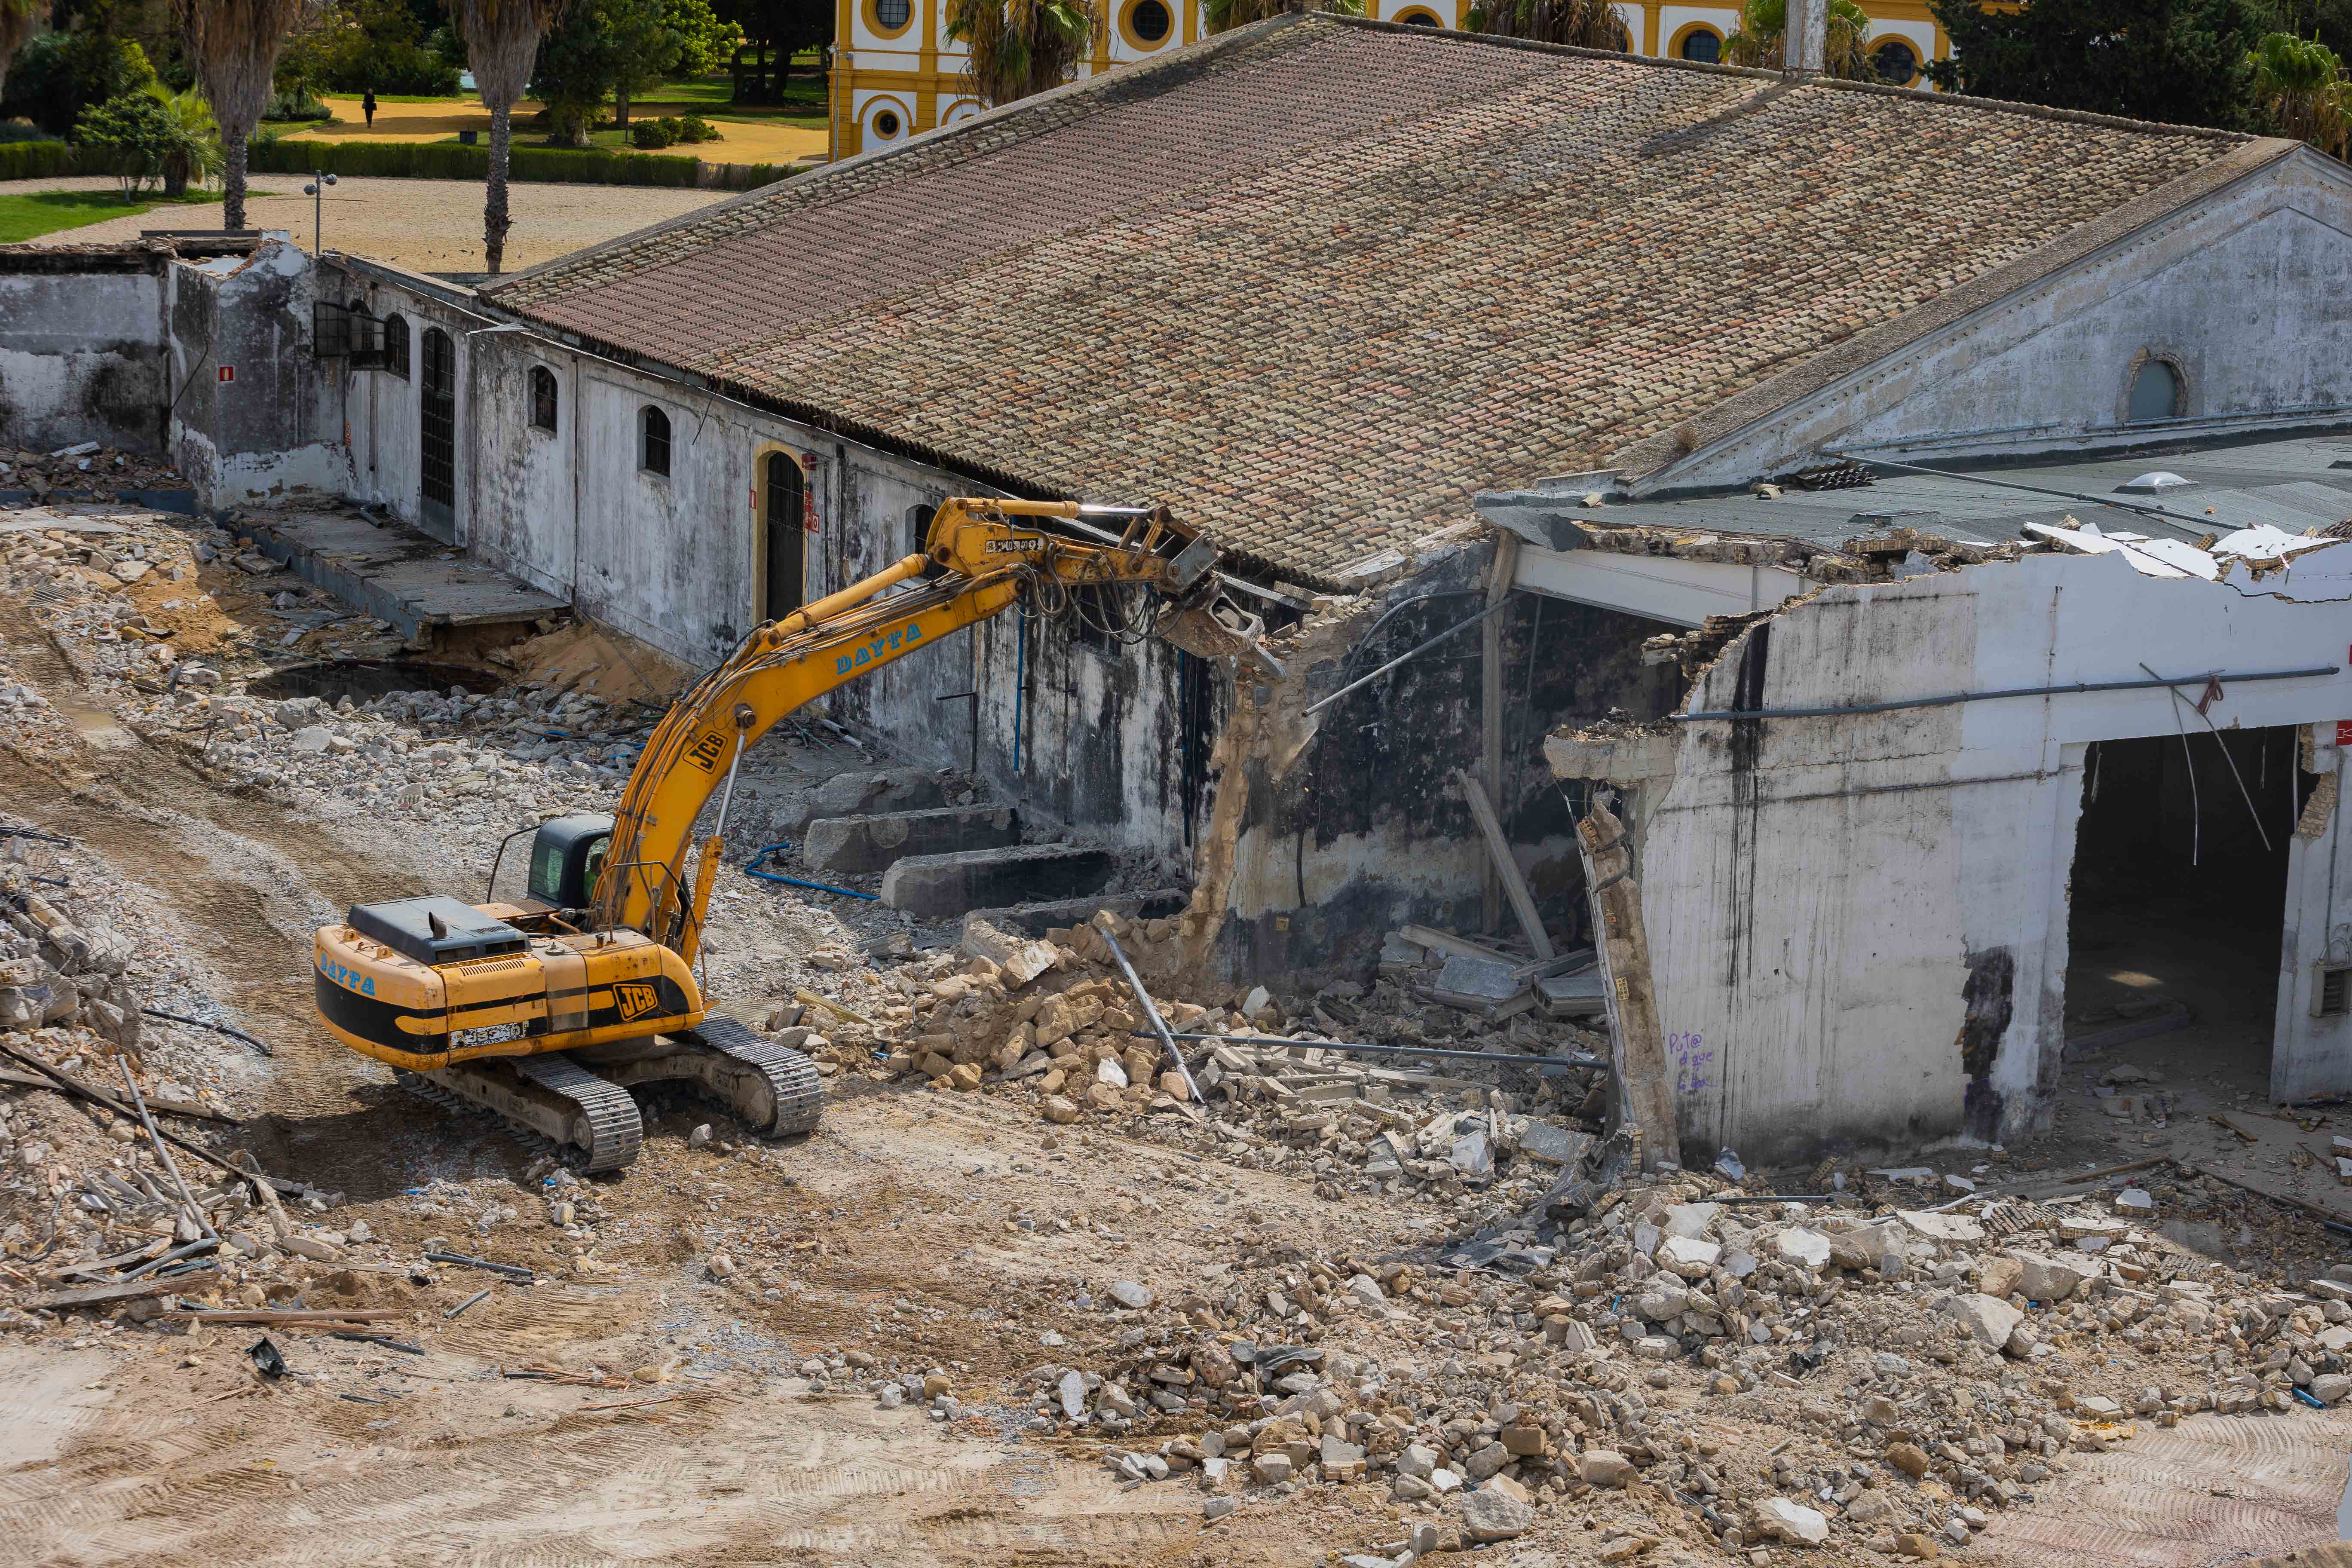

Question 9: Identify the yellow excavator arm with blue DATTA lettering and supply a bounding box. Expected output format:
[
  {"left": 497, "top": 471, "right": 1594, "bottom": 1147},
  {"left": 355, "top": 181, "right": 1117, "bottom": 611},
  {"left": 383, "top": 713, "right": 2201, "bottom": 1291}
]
[{"left": 593, "top": 498, "right": 1254, "bottom": 964}]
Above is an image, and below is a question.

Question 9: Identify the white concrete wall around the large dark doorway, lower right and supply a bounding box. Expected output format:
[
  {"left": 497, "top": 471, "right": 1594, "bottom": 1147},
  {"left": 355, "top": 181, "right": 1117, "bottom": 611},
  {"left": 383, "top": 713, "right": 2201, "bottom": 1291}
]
[{"left": 1642, "top": 545, "right": 2352, "bottom": 1161}]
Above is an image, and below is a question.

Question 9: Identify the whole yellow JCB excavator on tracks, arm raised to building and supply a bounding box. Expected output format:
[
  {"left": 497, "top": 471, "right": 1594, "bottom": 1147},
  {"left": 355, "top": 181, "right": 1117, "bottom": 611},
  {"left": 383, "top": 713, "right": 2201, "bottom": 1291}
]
[{"left": 313, "top": 498, "right": 1263, "bottom": 1173}]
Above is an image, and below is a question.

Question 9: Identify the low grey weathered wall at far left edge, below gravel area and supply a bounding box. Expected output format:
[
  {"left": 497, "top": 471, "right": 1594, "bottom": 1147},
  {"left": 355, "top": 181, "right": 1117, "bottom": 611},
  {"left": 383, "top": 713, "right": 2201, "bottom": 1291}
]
[{"left": 0, "top": 245, "right": 172, "bottom": 456}]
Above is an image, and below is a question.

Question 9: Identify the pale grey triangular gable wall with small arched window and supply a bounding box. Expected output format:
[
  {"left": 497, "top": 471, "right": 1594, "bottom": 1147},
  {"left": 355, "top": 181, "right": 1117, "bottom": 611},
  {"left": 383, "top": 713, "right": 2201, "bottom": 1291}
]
[{"left": 1642, "top": 150, "right": 2352, "bottom": 491}]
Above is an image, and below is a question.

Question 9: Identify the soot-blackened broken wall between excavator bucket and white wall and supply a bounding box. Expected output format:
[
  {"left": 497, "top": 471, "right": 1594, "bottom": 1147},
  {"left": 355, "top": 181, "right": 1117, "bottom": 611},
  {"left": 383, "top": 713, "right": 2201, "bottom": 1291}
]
[{"left": 1192, "top": 543, "right": 1679, "bottom": 978}]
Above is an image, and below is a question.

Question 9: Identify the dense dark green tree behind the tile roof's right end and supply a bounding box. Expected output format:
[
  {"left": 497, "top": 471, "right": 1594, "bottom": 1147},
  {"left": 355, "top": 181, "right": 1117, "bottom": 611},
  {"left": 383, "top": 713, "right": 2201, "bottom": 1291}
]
[{"left": 1929, "top": 0, "right": 2269, "bottom": 129}]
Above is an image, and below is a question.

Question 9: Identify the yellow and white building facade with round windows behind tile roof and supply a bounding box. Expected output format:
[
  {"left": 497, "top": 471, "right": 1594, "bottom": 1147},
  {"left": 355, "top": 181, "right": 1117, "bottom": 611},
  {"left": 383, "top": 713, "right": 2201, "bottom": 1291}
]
[{"left": 828, "top": 0, "right": 1952, "bottom": 160}]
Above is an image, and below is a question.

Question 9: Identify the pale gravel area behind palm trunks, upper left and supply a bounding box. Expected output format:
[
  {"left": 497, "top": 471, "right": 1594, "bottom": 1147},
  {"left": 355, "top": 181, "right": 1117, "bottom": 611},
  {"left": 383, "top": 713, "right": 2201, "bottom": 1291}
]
[{"left": 14, "top": 174, "right": 732, "bottom": 273}]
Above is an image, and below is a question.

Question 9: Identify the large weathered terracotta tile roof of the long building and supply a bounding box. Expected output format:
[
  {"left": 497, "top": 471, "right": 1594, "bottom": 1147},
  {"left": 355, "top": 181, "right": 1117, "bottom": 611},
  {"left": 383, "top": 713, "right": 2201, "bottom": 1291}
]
[{"left": 489, "top": 16, "right": 2246, "bottom": 583}]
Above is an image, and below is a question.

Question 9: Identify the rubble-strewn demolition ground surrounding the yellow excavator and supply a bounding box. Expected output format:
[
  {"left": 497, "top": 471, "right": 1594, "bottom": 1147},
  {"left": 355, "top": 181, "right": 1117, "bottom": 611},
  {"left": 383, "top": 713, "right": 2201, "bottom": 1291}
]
[{"left": 0, "top": 484, "right": 2352, "bottom": 1568}]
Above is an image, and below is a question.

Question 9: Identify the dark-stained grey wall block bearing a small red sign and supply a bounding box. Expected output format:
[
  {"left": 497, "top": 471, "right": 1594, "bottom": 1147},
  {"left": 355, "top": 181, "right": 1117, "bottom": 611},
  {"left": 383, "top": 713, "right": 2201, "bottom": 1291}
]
[{"left": 172, "top": 235, "right": 350, "bottom": 508}]
